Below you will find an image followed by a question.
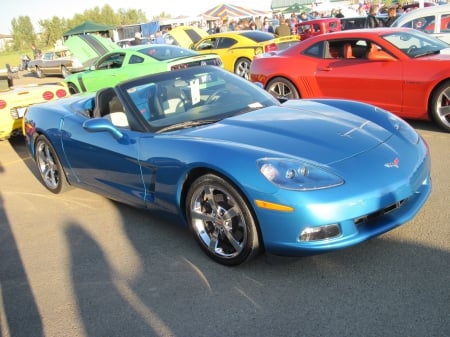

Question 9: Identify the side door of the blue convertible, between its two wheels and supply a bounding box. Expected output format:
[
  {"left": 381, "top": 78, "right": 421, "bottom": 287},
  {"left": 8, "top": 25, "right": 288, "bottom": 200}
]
[{"left": 61, "top": 109, "right": 146, "bottom": 207}]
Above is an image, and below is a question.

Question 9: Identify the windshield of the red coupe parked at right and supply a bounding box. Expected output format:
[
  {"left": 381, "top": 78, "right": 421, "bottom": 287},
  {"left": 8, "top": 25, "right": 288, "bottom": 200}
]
[{"left": 383, "top": 29, "right": 449, "bottom": 58}]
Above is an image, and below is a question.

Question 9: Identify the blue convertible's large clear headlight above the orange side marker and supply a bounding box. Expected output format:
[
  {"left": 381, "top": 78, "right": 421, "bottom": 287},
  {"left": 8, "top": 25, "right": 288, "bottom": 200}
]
[{"left": 257, "top": 158, "right": 344, "bottom": 191}]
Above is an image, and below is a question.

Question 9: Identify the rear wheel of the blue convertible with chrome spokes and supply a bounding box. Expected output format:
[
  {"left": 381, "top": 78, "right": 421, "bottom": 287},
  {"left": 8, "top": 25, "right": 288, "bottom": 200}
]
[{"left": 35, "top": 135, "right": 69, "bottom": 194}]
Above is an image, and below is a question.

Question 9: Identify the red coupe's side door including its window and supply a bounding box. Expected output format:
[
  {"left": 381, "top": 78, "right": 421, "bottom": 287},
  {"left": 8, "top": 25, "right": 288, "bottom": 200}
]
[{"left": 315, "top": 39, "right": 403, "bottom": 112}]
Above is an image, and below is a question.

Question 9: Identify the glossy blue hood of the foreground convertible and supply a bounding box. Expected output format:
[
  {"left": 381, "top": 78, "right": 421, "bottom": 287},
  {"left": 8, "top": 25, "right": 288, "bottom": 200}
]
[{"left": 181, "top": 105, "right": 392, "bottom": 164}]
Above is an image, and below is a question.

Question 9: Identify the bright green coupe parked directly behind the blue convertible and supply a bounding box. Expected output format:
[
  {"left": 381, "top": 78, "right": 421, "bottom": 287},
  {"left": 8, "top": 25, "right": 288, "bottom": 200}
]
[{"left": 65, "top": 44, "right": 223, "bottom": 94}]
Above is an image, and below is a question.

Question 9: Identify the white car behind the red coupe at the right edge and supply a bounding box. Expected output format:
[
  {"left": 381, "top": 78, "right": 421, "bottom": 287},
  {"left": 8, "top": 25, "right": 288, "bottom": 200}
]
[{"left": 392, "top": 5, "right": 450, "bottom": 44}]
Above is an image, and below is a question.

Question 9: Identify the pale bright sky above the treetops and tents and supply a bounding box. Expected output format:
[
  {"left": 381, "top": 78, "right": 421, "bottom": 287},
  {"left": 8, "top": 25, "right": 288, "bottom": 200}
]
[{"left": 0, "top": 0, "right": 272, "bottom": 34}]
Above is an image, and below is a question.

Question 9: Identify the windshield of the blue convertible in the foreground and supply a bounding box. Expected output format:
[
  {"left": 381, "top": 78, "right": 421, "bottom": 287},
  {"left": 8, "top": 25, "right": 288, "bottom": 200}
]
[{"left": 120, "top": 66, "right": 279, "bottom": 132}]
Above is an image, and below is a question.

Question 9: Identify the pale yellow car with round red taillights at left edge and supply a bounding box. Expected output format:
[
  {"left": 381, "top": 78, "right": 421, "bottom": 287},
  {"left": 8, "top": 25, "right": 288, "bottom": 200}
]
[{"left": 0, "top": 75, "right": 69, "bottom": 140}]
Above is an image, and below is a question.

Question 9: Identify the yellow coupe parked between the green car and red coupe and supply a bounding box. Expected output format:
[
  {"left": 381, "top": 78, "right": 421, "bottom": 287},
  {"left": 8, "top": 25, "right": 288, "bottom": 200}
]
[{"left": 192, "top": 30, "right": 300, "bottom": 79}]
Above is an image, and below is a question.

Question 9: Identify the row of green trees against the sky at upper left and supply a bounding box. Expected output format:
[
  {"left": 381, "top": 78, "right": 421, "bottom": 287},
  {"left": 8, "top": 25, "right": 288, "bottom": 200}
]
[{"left": 5, "top": 4, "right": 148, "bottom": 51}]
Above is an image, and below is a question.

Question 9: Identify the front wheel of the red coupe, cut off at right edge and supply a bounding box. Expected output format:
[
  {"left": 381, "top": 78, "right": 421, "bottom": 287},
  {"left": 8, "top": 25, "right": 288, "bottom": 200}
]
[{"left": 429, "top": 81, "right": 450, "bottom": 132}]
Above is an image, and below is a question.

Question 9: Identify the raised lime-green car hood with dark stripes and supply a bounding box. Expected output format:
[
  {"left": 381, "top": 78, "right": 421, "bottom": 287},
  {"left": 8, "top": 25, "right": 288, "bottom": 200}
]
[{"left": 64, "top": 34, "right": 120, "bottom": 68}]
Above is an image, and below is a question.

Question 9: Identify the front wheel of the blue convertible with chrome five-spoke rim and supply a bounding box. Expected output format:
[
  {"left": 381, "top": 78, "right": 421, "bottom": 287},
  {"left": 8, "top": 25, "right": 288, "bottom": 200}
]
[{"left": 185, "top": 174, "right": 259, "bottom": 266}]
